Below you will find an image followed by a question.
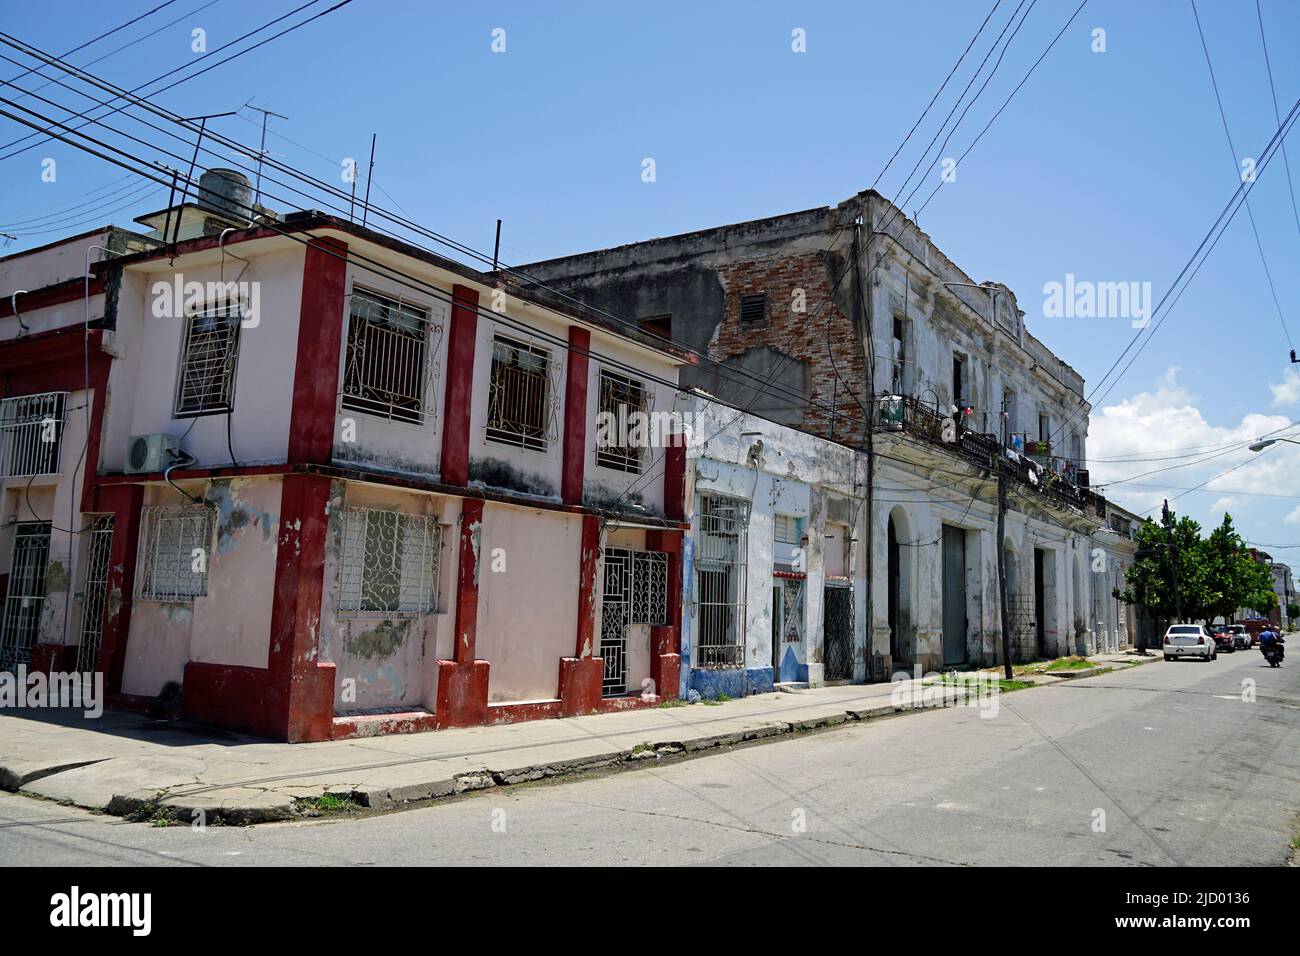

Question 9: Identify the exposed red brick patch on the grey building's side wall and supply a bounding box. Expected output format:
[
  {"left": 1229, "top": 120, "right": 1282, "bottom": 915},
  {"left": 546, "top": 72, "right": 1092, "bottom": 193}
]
[{"left": 709, "top": 252, "right": 866, "bottom": 444}]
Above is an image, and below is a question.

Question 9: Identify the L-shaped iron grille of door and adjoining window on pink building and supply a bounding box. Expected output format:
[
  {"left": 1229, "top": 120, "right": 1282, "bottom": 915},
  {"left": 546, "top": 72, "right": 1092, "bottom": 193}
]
[{"left": 601, "top": 548, "right": 668, "bottom": 695}]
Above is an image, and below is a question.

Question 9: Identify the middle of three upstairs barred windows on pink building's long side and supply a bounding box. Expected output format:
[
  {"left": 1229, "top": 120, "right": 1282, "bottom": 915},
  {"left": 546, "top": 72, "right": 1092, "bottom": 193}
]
[{"left": 488, "top": 336, "right": 560, "bottom": 451}]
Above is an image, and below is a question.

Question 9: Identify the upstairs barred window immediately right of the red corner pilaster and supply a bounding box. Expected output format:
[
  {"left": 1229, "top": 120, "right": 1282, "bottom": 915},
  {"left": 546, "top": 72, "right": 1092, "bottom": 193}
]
[{"left": 342, "top": 287, "right": 442, "bottom": 424}]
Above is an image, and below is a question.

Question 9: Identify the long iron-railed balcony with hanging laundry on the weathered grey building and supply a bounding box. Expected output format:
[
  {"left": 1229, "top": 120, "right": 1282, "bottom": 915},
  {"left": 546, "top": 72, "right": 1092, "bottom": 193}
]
[{"left": 874, "top": 395, "right": 1106, "bottom": 519}]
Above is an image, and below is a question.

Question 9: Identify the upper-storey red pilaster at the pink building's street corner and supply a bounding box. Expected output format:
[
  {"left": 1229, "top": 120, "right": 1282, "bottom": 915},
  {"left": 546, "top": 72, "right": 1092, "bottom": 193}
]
[{"left": 289, "top": 237, "right": 347, "bottom": 464}]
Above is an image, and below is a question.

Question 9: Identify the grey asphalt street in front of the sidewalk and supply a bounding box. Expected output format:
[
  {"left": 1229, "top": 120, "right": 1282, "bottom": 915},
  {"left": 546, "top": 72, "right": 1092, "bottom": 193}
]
[{"left": 0, "top": 650, "right": 1300, "bottom": 866}]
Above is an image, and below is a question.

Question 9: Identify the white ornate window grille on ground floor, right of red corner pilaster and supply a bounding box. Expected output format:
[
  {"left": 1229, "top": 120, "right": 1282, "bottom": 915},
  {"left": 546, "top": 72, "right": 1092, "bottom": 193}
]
[{"left": 338, "top": 509, "right": 442, "bottom": 617}]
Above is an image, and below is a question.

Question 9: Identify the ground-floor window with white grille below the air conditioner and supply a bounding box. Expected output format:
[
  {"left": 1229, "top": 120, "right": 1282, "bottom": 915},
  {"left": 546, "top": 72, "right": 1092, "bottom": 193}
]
[{"left": 135, "top": 506, "right": 212, "bottom": 601}]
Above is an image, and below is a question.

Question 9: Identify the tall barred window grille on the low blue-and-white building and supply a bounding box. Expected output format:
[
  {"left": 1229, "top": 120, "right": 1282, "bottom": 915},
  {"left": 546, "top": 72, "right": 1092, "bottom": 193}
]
[{"left": 693, "top": 494, "right": 749, "bottom": 667}]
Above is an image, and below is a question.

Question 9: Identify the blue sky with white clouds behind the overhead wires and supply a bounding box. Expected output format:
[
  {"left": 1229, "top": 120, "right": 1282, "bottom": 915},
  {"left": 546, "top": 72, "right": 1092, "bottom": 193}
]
[{"left": 0, "top": 0, "right": 1300, "bottom": 567}]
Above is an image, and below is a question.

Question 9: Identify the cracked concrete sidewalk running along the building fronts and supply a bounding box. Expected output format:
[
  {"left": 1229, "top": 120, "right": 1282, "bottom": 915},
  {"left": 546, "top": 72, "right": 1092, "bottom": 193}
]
[{"left": 0, "top": 654, "right": 1160, "bottom": 823}]
